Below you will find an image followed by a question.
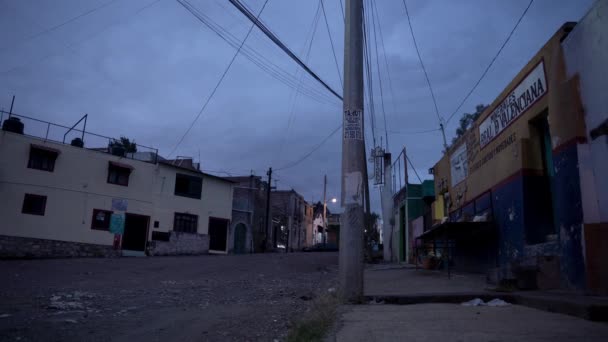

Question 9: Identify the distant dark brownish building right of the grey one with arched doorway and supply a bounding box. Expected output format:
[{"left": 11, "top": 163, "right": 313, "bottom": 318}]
[{"left": 270, "top": 190, "right": 307, "bottom": 251}]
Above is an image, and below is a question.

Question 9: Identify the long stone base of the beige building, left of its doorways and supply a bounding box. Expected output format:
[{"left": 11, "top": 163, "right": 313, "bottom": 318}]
[{"left": 0, "top": 235, "right": 120, "bottom": 259}]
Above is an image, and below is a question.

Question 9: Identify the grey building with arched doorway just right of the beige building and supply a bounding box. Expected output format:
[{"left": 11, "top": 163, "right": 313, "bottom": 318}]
[{"left": 226, "top": 175, "right": 268, "bottom": 254}]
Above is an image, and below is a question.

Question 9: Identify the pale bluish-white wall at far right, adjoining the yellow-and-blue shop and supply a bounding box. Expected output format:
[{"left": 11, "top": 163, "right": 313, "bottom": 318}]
[{"left": 560, "top": 0, "right": 608, "bottom": 295}]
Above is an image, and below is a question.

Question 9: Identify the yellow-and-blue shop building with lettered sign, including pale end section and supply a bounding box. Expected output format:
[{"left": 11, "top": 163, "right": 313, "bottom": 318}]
[{"left": 423, "top": 6, "right": 608, "bottom": 294}]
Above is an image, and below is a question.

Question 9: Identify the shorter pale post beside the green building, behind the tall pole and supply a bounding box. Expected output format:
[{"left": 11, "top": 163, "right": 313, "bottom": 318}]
[{"left": 380, "top": 153, "right": 395, "bottom": 262}]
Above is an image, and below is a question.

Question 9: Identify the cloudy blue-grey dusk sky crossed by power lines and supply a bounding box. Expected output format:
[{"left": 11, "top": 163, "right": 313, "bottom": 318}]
[{"left": 0, "top": 0, "right": 593, "bottom": 211}]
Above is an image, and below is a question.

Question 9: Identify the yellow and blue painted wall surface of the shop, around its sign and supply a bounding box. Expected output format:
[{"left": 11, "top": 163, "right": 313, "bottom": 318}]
[{"left": 428, "top": 23, "right": 592, "bottom": 290}]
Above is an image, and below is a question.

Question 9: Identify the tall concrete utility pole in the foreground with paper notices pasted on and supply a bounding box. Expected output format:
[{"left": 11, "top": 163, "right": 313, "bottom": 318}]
[{"left": 339, "top": 0, "right": 367, "bottom": 302}]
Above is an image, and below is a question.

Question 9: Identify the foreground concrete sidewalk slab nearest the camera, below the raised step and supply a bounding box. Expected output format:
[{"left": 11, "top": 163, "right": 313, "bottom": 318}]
[{"left": 330, "top": 304, "right": 608, "bottom": 342}]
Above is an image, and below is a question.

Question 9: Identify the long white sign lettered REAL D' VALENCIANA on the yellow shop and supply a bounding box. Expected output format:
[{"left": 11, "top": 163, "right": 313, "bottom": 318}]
[{"left": 479, "top": 61, "right": 547, "bottom": 148}]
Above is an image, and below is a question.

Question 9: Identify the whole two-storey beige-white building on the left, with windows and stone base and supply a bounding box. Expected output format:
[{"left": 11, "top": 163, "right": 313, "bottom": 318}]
[{"left": 0, "top": 117, "right": 232, "bottom": 258}]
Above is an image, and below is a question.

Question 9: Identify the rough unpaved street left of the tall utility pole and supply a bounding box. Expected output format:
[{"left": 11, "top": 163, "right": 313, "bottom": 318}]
[{"left": 0, "top": 253, "right": 337, "bottom": 342}]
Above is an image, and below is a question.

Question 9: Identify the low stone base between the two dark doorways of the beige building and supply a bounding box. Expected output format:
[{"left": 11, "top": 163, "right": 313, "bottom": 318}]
[{"left": 148, "top": 231, "right": 209, "bottom": 256}]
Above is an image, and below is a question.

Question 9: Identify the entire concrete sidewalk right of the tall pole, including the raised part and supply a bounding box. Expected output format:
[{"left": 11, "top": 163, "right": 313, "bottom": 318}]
[{"left": 329, "top": 265, "right": 608, "bottom": 341}]
